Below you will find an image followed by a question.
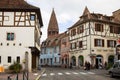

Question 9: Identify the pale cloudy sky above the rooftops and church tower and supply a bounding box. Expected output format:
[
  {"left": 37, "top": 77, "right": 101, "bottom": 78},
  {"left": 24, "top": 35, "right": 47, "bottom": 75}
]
[{"left": 26, "top": 0, "right": 120, "bottom": 41}]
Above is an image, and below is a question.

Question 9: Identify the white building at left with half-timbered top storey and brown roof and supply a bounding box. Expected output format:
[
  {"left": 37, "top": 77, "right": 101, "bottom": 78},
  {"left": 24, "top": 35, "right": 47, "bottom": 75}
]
[{"left": 0, "top": 0, "right": 43, "bottom": 71}]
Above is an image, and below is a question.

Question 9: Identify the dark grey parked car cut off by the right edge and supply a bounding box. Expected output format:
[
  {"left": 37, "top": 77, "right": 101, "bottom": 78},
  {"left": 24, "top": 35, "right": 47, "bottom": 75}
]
[{"left": 109, "top": 60, "right": 120, "bottom": 77}]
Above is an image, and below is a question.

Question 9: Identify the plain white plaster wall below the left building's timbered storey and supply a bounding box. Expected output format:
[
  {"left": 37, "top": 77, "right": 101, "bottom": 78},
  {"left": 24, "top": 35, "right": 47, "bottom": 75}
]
[{"left": 0, "top": 27, "right": 34, "bottom": 70}]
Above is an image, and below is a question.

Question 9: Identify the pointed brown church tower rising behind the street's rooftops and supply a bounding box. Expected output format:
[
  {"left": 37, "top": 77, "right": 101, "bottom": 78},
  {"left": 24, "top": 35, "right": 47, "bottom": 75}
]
[{"left": 47, "top": 9, "right": 59, "bottom": 38}]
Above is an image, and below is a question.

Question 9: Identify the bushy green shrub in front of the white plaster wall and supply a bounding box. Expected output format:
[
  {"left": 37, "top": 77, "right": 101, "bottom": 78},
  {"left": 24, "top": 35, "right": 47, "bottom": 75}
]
[{"left": 9, "top": 62, "right": 22, "bottom": 73}]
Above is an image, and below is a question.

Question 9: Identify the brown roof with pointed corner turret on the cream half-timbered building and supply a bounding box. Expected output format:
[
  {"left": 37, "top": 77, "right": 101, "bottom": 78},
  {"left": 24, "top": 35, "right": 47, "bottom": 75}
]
[{"left": 68, "top": 7, "right": 120, "bottom": 29}]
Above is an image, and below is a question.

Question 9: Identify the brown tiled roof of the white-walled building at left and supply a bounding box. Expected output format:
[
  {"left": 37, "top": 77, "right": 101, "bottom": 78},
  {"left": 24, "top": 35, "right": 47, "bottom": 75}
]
[{"left": 0, "top": 0, "right": 43, "bottom": 26}]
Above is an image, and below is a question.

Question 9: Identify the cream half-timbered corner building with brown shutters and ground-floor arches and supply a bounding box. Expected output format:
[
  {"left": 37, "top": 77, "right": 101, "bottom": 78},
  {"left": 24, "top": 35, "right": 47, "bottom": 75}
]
[{"left": 68, "top": 7, "right": 120, "bottom": 68}]
